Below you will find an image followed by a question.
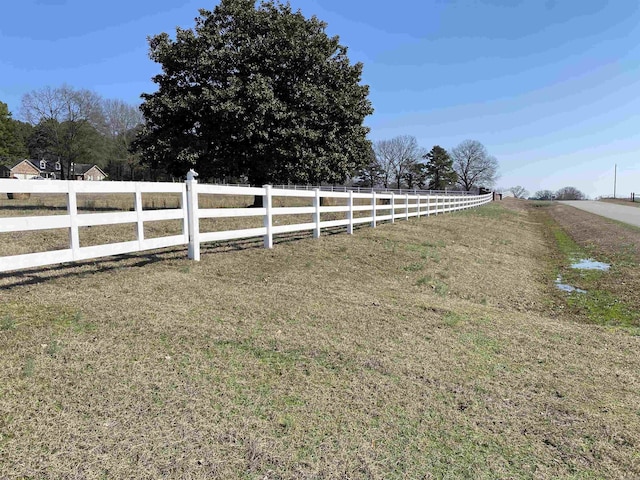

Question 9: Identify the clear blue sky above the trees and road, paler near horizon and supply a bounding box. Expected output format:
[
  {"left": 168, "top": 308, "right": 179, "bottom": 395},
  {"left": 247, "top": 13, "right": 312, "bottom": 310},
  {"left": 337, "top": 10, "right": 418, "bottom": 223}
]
[{"left": 0, "top": 0, "right": 640, "bottom": 197}]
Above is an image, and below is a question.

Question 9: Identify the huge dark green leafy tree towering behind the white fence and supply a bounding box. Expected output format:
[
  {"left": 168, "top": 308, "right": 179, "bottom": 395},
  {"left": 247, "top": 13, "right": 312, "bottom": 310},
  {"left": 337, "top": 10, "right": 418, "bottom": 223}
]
[{"left": 136, "top": 0, "right": 373, "bottom": 190}]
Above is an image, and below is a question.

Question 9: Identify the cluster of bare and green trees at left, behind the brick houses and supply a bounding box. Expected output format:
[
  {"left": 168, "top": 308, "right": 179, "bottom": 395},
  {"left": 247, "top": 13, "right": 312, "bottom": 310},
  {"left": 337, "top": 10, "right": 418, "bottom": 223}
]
[{"left": 0, "top": 85, "right": 148, "bottom": 180}]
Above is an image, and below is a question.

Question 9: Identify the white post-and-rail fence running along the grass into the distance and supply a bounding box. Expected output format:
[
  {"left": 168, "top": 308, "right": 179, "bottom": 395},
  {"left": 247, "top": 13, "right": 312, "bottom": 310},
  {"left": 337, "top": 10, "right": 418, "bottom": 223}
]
[{"left": 0, "top": 171, "right": 492, "bottom": 272}]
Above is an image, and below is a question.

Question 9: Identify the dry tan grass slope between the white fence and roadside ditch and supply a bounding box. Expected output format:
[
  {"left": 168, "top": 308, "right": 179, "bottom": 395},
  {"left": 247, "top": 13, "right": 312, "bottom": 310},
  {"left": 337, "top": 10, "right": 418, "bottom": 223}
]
[{"left": 0, "top": 200, "right": 640, "bottom": 479}]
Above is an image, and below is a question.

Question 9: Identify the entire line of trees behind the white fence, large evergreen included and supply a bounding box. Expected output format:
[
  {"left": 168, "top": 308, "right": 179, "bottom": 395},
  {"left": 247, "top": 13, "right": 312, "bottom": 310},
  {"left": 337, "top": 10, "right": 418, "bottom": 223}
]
[{"left": 0, "top": 0, "right": 498, "bottom": 190}]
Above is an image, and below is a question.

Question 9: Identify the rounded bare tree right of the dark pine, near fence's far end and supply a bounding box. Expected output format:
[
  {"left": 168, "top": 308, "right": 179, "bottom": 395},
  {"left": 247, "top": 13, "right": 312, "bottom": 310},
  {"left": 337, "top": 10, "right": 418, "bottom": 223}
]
[{"left": 450, "top": 140, "right": 498, "bottom": 191}]
